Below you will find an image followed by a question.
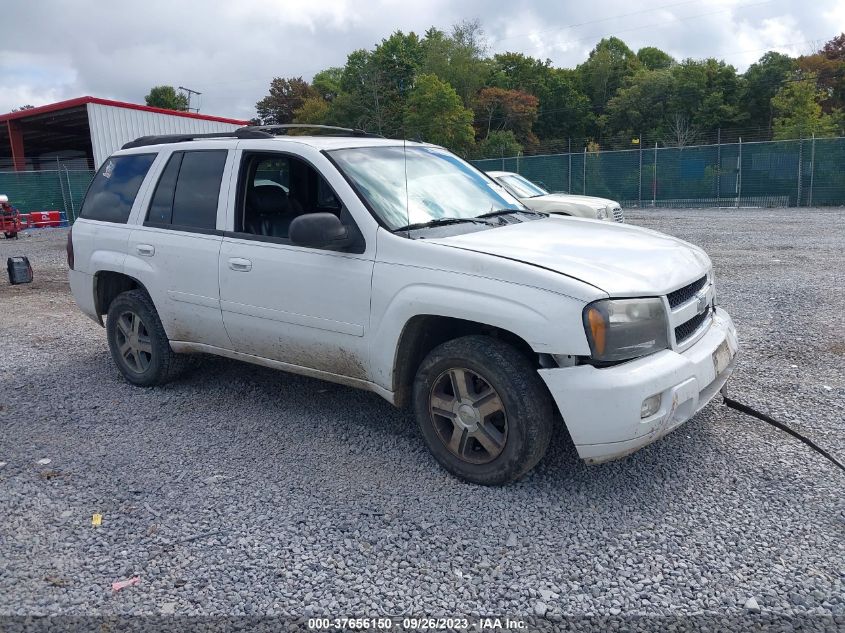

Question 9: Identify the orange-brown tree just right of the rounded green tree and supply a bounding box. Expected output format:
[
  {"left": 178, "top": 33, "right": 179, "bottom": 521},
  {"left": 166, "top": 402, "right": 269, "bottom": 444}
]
[{"left": 475, "top": 88, "right": 538, "bottom": 145}]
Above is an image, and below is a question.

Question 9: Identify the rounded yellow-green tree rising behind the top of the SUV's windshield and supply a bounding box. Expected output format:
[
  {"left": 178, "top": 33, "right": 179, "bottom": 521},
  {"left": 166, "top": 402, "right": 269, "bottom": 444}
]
[{"left": 405, "top": 75, "right": 475, "bottom": 154}]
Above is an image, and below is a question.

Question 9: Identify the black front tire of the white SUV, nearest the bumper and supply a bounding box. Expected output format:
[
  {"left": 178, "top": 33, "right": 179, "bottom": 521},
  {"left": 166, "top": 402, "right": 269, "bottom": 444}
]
[{"left": 413, "top": 336, "right": 554, "bottom": 486}]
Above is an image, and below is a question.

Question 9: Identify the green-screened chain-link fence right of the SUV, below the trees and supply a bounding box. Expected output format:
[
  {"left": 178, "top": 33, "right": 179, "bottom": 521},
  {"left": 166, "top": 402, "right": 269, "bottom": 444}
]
[{"left": 474, "top": 137, "right": 845, "bottom": 207}]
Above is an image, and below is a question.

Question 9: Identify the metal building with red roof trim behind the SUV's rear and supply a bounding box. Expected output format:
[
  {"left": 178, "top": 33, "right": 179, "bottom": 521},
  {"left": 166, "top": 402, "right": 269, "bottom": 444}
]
[{"left": 0, "top": 97, "right": 249, "bottom": 172}]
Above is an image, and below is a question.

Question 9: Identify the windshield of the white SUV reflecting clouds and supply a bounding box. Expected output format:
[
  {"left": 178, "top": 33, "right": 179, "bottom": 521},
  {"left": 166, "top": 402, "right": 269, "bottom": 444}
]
[{"left": 329, "top": 145, "right": 525, "bottom": 230}]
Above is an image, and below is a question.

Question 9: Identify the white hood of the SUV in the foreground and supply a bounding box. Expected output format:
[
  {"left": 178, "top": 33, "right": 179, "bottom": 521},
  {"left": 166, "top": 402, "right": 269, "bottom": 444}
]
[{"left": 426, "top": 216, "right": 710, "bottom": 297}]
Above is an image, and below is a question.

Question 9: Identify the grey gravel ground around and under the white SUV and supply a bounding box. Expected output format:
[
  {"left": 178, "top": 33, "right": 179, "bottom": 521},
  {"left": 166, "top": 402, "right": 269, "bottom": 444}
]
[{"left": 0, "top": 209, "right": 845, "bottom": 628}]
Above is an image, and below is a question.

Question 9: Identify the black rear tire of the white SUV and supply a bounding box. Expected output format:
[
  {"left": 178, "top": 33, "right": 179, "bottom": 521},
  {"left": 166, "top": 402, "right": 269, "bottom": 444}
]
[{"left": 106, "top": 290, "right": 188, "bottom": 387}]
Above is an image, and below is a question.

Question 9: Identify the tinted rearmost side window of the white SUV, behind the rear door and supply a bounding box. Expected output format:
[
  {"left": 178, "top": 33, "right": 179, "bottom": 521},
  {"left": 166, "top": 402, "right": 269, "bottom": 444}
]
[{"left": 80, "top": 154, "right": 156, "bottom": 223}]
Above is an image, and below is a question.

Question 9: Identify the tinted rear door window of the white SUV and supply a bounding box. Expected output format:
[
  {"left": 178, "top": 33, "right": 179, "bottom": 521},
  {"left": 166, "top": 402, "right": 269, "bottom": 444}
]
[{"left": 146, "top": 150, "right": 227, "bottom": 231}]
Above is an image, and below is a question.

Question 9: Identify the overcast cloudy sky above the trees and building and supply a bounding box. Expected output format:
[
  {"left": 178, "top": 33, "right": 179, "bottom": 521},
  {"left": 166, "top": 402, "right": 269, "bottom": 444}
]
[{"left": 0, "top": 0, "right": 845, "bottom": 118}]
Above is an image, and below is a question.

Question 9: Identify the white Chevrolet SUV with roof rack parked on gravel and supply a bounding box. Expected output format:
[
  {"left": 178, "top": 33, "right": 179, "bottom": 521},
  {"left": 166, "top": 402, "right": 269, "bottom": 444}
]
[{"left": 68, "top": 126, "right": 737, "bottom": 484}]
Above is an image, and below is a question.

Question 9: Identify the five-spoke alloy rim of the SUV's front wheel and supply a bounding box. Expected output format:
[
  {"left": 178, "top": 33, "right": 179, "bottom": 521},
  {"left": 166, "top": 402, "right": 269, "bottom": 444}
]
[{"left": 429, "top": 367, "right": 508, "bottom": 464}]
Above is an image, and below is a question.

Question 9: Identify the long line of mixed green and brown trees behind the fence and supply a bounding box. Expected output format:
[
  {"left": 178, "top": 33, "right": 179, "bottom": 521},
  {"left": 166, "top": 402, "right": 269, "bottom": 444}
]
[{"left": 158, "top": 21, "right": 845, "bottom": 158}]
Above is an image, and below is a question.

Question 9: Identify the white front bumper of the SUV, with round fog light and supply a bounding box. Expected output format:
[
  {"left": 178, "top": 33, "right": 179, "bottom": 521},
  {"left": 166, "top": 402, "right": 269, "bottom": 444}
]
[{"left": 539, "top": 308, "right": 738, "bottom": 463}]
